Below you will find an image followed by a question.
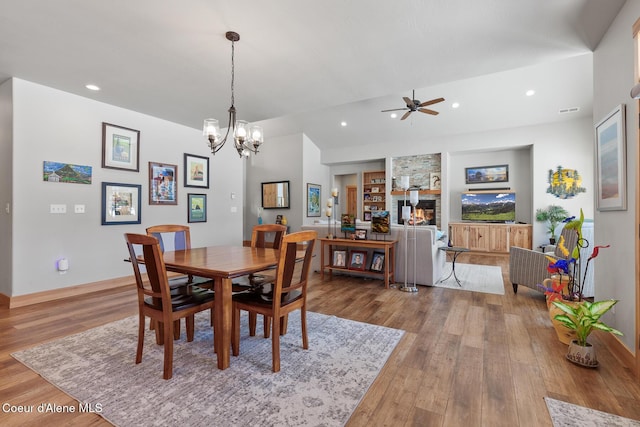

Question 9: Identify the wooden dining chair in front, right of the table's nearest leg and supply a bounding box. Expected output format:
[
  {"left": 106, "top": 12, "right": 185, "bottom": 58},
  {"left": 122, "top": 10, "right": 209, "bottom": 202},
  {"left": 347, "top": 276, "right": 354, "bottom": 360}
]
[{"left": 231, "top": 231, "right": 318, "bottom": 372}]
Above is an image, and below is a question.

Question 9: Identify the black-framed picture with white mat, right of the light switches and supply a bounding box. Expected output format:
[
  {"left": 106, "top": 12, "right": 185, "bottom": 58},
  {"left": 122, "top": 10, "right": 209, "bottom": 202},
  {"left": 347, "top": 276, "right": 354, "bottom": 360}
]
[{"left": 102, "top": 182, "right": 142, "bottom": 225}]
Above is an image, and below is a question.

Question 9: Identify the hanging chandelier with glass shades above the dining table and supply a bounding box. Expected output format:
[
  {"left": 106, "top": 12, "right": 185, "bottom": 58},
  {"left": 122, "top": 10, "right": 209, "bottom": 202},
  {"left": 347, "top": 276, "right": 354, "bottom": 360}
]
[{"left": 202, "top": 31, "right": 264, "bottom": 158}]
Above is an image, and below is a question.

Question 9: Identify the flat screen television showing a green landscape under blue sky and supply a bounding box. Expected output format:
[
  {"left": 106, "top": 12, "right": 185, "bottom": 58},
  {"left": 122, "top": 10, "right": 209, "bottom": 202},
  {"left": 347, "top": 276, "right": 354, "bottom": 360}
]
[{"left": 462, "top": 191, "right": 516, "bottom": 222}]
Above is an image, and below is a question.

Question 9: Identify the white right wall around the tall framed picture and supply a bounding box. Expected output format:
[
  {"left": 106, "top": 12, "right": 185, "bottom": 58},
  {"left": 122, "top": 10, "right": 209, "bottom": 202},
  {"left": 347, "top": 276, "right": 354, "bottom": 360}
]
[{"left": 593, "top": 0, "right": 640, "bottom": 352}]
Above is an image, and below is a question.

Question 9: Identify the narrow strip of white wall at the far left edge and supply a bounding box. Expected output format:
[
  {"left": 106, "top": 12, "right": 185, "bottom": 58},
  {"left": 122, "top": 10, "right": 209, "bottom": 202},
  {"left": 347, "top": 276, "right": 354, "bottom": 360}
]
[{"left": 0, "top": 80, "right": 13, "bottom": 295}]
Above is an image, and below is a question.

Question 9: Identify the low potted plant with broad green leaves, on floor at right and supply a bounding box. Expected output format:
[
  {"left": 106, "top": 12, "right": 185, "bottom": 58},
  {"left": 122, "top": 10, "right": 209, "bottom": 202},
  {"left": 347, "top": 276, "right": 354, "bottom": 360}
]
[{"left": 553, "top": 299, "right": 622, "bottom": 368}]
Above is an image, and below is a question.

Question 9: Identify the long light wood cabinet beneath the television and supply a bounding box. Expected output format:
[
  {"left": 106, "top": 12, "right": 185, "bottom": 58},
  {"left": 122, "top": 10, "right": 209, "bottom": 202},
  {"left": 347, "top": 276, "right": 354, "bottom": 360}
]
[{"left": 449, "top": 222, "right": 532, "bottom": 253}]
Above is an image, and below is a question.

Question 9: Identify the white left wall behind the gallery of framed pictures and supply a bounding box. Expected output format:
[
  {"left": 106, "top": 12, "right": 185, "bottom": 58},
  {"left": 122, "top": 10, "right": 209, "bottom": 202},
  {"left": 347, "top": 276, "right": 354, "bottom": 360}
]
[{"left": 11, "top": 79, "right": 244, "bottom": 296}]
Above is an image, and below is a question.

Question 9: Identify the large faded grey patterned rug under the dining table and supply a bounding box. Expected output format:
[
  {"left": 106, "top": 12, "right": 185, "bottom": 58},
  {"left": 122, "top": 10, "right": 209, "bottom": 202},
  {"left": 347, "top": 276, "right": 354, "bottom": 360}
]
[{"left": 12, "top": 313, "right": 404, "bottom": 426}]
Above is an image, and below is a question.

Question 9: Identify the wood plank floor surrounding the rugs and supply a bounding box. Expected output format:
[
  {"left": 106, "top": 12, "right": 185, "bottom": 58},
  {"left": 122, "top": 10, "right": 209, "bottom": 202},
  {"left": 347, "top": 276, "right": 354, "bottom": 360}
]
[{"left": 0, "top": 254, "right": 640, "bottom": 427}]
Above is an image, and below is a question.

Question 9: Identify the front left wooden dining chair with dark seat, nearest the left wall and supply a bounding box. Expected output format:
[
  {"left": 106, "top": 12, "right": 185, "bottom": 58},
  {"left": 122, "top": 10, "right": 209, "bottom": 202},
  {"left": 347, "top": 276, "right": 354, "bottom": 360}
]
[{"left": 125, "top": 233, "right": 214, "bottom": 380}]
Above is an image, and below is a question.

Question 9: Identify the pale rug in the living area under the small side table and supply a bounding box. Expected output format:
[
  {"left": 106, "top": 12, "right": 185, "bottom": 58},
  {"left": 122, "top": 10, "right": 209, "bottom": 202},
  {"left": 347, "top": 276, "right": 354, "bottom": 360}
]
[{"left": 434, "top": 262, "right": 504, "bottom": 295}]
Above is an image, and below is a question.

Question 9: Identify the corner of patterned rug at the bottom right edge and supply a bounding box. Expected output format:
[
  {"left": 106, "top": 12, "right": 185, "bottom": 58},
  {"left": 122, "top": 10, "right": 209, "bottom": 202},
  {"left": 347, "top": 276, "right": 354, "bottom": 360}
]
[{"left": 544, "top": 397, "right": 640, "bottom": 427}]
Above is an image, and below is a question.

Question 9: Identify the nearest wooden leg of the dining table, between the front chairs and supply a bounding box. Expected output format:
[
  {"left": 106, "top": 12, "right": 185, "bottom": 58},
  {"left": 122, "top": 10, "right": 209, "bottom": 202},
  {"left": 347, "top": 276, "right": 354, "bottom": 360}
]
[{"left": 213, "top": 278, "right": 233, "bottom": 369}]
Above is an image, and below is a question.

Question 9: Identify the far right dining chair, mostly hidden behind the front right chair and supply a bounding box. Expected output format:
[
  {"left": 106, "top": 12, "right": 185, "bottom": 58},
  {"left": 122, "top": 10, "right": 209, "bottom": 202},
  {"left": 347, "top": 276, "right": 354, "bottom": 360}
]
[{"left": 237, "top": 224, "right": 287, "bottom": 338}]
